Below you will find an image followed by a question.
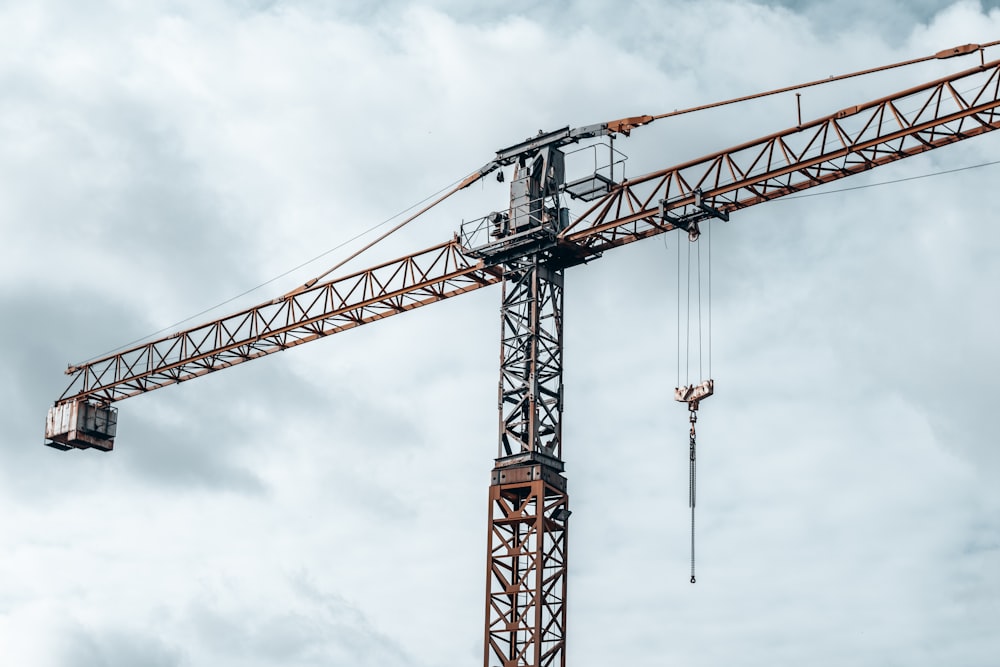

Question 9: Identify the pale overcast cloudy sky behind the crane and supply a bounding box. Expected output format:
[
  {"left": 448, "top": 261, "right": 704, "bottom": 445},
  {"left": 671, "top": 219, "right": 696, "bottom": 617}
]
[{"left": 0, "top": 0, "right": 1000, "bottom": 667}]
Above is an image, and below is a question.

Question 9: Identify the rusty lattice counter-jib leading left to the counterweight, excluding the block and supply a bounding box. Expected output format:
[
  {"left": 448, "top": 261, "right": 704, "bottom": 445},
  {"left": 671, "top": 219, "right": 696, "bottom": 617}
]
[{"left": 56, "top": 240, "right": 501, "bottom": 405}]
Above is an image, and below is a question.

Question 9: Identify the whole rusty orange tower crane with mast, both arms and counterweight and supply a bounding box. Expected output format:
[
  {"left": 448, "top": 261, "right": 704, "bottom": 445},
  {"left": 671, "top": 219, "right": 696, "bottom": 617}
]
[{"left": 45, "top": 42, "right": 1000, "bottom": 667}]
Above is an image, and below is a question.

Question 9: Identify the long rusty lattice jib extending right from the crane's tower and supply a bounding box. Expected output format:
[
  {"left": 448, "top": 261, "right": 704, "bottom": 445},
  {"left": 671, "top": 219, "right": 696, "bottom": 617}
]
[{"left": 560, "top": 60, "right": 1000, "bottom": 256}]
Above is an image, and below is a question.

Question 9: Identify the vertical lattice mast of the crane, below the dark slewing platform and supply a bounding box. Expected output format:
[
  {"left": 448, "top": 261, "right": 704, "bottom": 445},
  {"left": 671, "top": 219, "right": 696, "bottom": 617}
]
[{"left": 484, "top": 237, "right": 569, "bottom": 667}]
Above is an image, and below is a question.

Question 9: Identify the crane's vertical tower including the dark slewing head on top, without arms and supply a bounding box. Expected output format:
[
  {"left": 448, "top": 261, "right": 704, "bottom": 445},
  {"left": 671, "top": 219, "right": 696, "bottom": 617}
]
[{"left": 478, "top": 144, "right": 569, "bottom": 667}]
